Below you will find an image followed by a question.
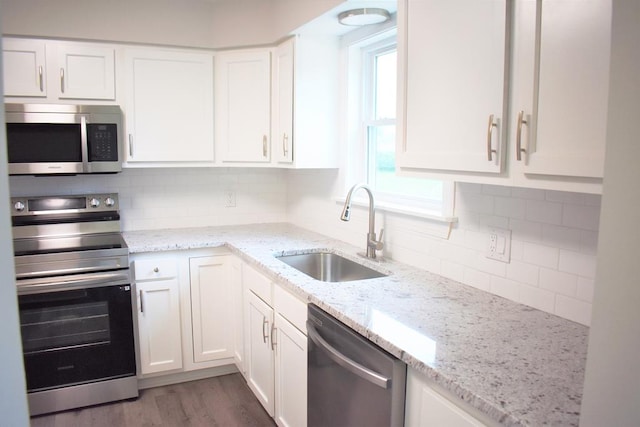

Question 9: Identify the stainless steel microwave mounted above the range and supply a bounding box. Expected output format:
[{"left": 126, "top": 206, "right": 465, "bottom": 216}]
[{"left": 5, "top": 104, "right": 122, "bottom": 175}]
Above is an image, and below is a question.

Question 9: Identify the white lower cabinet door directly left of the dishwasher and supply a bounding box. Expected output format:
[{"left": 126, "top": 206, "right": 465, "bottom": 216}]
[{"left": 275, "top": 313, "right": 307, "bottom": 427}]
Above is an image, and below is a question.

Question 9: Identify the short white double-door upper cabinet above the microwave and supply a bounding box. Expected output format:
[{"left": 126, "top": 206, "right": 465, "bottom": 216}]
[{"left": 3, "top": 38, "right": 115, "bottom": 102}]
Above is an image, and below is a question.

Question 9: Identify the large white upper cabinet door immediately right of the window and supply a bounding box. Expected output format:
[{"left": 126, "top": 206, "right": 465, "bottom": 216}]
[{"left": 396, "top": 0, "right": 509, "bottom": 173}]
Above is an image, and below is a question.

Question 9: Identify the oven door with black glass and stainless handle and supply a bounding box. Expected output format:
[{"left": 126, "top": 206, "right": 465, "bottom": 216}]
[{"left": 18, "top": 271, "right": 136, "bottom": 392}]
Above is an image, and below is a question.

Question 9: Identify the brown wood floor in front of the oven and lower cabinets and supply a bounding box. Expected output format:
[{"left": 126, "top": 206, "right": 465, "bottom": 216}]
[{"left": 29, "top": 373, "right": 275, "bottom": 427}]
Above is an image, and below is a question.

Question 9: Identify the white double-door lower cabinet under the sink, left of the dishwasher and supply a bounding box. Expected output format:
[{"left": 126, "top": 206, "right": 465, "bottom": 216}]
[{"left": 242, "top": 264, "right": 307, "bottom": 427}]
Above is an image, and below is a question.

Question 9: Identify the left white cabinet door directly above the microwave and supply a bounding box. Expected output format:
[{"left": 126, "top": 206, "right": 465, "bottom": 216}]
[{"left": 2, "top": 38, "right": 47, "bottom": 98}]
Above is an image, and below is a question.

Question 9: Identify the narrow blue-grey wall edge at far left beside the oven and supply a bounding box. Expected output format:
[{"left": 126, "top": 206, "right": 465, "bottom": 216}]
[{"left": 0, "top": 13, "right": 29, "bottom": 427}]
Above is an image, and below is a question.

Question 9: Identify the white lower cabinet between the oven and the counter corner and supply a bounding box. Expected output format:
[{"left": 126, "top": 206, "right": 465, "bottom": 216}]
[{"left": 133, "top": 251, "right": 235, "bottom": 377}]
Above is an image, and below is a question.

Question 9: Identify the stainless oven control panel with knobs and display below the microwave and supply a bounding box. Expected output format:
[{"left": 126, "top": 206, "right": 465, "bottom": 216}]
[{"left": 11, "top": 193, "right": 119, "bottom": 216}]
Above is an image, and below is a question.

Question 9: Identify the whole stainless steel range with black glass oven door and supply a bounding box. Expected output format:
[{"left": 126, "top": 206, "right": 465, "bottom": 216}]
[{"left": 11, "top": 194, "right": 138, "bottom": 415}]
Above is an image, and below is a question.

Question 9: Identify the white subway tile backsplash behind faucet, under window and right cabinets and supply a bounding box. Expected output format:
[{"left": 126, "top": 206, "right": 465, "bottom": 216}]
[{"left": 288, "top": 171, "right": 600, "bottom": 325}]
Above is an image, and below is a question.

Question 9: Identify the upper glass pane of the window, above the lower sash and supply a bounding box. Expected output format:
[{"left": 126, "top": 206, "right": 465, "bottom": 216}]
[{"left": 373, "top": 50, "right": 397, "bottom": 120}]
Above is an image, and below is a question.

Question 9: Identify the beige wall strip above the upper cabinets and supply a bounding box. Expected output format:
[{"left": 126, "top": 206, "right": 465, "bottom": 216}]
[{"left": 0, "top": 0, "right": 343, "bottom": 48}]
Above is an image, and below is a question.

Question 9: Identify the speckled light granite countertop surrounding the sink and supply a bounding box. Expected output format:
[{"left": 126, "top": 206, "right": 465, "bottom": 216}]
[{"left": 123, "top": 224, "right": 589, "bottom": 426}]
